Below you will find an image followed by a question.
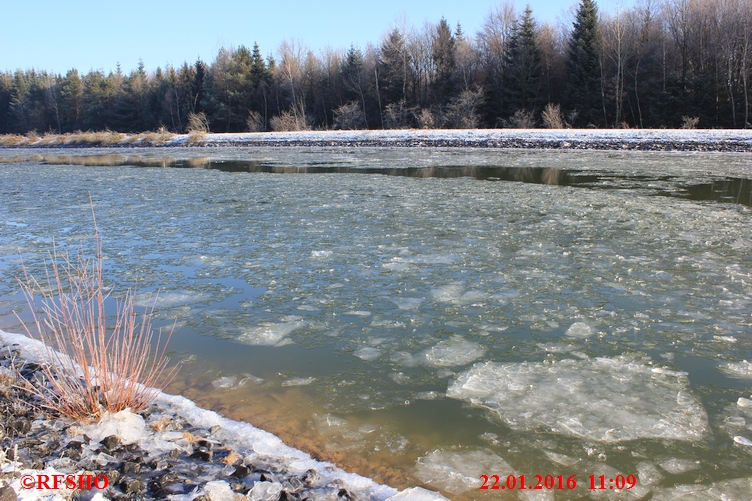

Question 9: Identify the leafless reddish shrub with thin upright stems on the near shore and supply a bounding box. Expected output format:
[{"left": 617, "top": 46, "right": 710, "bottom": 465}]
[{"left": 21, "top": 207, "right": 177, "bottom": 422}]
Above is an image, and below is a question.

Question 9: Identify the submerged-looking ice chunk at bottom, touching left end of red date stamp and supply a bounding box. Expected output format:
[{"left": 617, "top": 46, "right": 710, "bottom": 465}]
[{"left": 415, "top": 449, "right": 514, "bottom": 494}]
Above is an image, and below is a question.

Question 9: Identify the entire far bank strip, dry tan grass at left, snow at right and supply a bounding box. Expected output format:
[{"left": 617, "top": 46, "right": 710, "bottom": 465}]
[{"left": 0, "top": 129, "right": 752, "bottom": 152}]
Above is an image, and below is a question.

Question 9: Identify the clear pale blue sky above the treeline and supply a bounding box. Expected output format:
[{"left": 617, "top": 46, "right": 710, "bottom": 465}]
[{"left": 0, "top": 0, "right": 616, "bottom": 74}]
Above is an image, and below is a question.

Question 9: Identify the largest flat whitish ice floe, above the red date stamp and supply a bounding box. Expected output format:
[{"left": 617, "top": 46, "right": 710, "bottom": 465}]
[{"left": 447, "top": 356, "right": 708, "bottom": 442}]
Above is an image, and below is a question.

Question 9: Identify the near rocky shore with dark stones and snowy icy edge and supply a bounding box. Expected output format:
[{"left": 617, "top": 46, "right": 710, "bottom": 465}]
[{"left": 0, "top": 333, "right": 444, "bottom": 501}]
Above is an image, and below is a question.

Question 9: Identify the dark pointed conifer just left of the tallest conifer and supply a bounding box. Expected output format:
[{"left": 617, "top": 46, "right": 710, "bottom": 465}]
[{"left": 502, "top": 6, "right": 543, "bottom": 115}]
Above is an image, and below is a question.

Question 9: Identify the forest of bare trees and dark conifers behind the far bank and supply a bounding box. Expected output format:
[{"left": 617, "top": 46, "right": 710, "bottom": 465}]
[{"left": 0, "top": 0, "right": 752, "bottom": 134}]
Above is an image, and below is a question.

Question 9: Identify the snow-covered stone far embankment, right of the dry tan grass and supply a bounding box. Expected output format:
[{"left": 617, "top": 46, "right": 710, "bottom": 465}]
[{"left": 169, "top": 129, "right": 752, "bottom": 151}]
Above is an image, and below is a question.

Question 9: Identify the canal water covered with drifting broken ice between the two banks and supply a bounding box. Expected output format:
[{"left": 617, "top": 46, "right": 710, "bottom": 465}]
[{"left": 0, "top": 148, "right": 752, "bottom": 499}]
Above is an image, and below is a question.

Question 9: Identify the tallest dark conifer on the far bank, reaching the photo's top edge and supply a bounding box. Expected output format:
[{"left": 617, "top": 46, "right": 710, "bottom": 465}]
[{"left": 564, "top": 0, "right": 604, "bottom": 126}]
